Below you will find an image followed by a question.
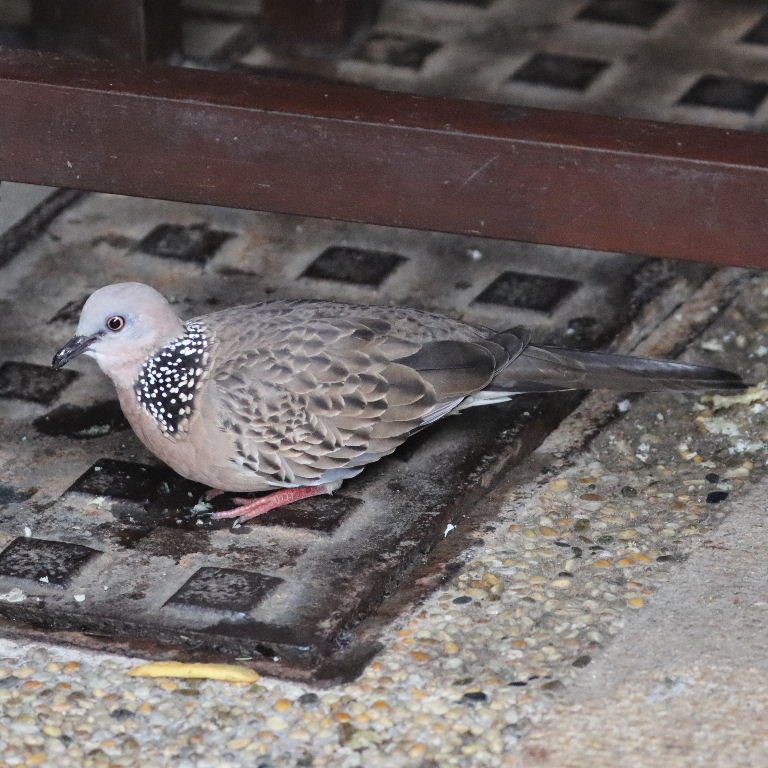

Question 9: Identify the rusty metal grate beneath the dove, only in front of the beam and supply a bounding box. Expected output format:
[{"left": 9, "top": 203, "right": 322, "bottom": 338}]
[{"left": 0, "top": 184, "right": 707, "bottom": 679}]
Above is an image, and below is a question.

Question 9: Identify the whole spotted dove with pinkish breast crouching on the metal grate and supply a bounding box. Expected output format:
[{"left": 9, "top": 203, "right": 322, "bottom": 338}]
[{"left": 53, "top": 283, "right": 744, "bottom": 519}]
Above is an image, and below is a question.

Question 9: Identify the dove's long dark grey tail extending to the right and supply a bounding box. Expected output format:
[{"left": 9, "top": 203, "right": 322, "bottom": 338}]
[{"left": 485, "top": 344, "right": 747, "bottom": 394}]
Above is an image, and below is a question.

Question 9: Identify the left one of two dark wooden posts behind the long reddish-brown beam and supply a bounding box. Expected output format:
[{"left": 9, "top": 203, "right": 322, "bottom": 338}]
[{"left": 32, "top": 0, "right": 181, "bottom": 62}]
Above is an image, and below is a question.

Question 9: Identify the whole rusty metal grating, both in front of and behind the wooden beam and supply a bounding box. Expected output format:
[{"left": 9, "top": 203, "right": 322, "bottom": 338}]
[{"left": 0, "top": 0, "right": 756, "bottom": 679}]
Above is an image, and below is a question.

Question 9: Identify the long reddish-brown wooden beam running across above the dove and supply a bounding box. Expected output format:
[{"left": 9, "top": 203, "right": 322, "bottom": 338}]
[{"left": 0, "top": 50, "right": 768, "bottom": 267}]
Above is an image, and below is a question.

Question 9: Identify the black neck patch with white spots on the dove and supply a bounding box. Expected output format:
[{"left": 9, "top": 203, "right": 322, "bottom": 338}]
[{"left": 133, "top": 323, "right": 209, "bottom": 435}]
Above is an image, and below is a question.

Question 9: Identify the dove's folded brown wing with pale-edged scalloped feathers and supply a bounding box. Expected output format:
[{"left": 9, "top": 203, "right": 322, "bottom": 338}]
[{"left": 198, "top": 302, "right": 527, "bottom": 485}]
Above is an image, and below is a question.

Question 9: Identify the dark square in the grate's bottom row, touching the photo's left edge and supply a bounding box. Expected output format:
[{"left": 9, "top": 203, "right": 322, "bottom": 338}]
[{"left": 0, "top": 537, "right": 99, "bottom": 587}]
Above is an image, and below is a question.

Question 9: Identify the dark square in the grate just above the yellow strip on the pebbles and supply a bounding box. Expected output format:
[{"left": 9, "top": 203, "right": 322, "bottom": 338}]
[{"left": 166, "top": 567, "right": 283, "bottom": 613}]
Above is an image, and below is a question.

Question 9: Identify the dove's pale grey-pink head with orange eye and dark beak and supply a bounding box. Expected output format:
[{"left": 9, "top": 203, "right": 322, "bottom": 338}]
[{"left": 52, "top": 283, "right": 184, "bottom": 379}]
